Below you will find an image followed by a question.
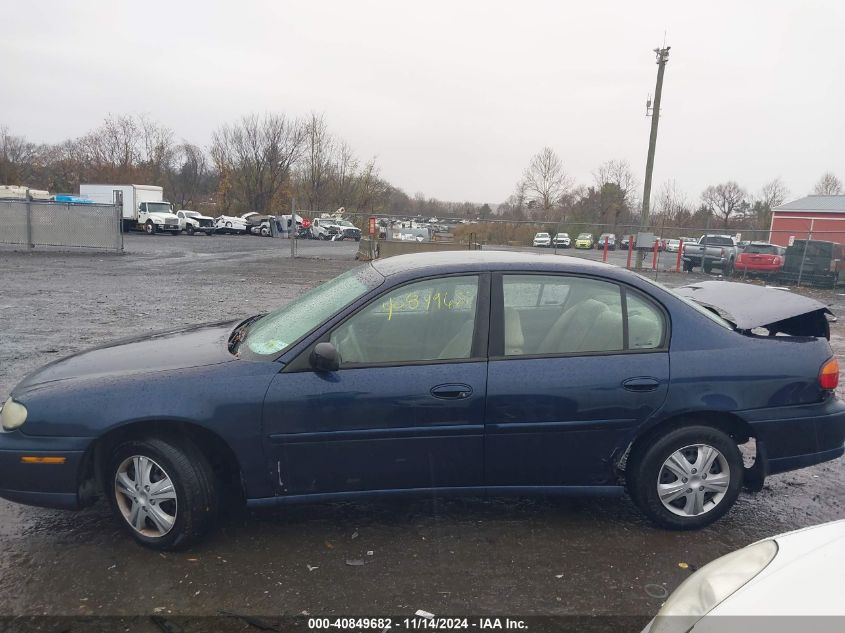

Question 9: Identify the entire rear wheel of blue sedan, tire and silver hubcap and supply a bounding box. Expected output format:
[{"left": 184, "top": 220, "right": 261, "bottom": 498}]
[{"left": 626, "top": 425, "right": 744, "bottom": 530}]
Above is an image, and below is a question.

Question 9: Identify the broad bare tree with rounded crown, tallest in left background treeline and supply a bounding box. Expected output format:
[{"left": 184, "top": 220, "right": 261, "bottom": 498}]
[{"left": 211, "top": 114, "right": 305, "bottom": 212}]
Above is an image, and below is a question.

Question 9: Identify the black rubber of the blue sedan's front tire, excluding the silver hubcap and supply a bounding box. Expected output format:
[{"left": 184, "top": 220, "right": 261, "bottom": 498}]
[{"left": 104, "top": 437, "right": 218, "bottom": 550}]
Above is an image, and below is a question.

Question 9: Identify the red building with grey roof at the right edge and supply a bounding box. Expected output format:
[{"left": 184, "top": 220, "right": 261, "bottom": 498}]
[{"left": 769, "top": 196, "right": 845, "bottom": 246}]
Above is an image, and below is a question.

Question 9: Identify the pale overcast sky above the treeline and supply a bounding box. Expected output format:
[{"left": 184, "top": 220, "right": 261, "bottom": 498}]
[{"left": 0, "top": 0, "right": 845, "bottom": 203}]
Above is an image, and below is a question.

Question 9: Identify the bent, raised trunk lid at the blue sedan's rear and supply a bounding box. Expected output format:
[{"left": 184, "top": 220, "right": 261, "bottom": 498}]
[{"left": 674, "top": 281, "right": 833, "bottom": 338}]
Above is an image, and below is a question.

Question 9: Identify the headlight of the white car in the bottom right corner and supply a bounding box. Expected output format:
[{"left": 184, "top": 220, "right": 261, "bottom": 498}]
[{"left": 649, "top": 540, "right": 778, "bottom": 633}]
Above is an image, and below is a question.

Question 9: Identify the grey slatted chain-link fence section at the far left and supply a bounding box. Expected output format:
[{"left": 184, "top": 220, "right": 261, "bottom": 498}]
[{"left": 0, "top": 200, "right": 123, "bottom": 252}]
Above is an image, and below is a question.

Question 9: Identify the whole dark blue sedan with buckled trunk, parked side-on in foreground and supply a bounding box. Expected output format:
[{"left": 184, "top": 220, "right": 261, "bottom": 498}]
[{"left": 0, "top": 252, "right": 845, "bottom": 549}]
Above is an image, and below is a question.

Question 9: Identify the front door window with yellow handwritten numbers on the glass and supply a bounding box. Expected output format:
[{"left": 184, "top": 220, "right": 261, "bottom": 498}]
[{"left": 329, "top": 275, "right": 478, "bottom": 367}]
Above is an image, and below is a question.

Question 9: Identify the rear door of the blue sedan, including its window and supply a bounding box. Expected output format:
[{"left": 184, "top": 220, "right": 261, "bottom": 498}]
[{"left": 485, "top": 274, "right": 669, "bottom": 486}]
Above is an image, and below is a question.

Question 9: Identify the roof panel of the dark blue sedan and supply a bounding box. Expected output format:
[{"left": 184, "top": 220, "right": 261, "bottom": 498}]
[{"left": 372, "top": 250, "right": 620, "bottom": 277}]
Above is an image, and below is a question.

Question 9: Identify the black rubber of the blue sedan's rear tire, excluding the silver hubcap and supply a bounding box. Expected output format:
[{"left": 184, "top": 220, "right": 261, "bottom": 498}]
[{"left": 625, "top": 425, "right": 744, "bottom": 530}]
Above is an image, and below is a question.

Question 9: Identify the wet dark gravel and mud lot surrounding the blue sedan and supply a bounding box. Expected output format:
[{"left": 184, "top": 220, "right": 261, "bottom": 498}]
[{"left": 0, "top": 235, "right": 845, "bottom": 628}]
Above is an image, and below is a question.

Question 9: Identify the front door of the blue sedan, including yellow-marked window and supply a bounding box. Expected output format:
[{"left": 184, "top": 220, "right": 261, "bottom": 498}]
[{"left": 264, "top": 275, "right": 489, "bottom": 495}]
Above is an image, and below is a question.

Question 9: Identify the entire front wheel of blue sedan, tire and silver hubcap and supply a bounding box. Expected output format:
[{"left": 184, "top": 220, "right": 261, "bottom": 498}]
[{"left": 106, "top": 437, "right": 217, "bottom": 550}]
